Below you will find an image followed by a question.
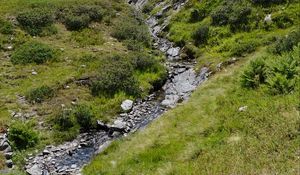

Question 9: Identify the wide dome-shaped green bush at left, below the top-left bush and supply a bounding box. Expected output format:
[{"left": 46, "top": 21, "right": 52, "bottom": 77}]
[{"left": 11, "top": 42, "right": 55, "bottom": 64}]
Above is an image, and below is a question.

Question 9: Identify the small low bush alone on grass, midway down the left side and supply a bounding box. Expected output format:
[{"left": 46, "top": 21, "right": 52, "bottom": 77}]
[{"left": 26, "top": 86, "right": 54, "bottom": 103}]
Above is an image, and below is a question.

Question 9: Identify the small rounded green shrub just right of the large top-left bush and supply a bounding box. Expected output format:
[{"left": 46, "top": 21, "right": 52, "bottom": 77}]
[{"left": 65, "top": 15, "right": 91, "bottom": 31}]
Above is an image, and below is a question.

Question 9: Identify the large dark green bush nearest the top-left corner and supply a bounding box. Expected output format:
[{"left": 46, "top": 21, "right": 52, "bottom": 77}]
[{"left": 17, "top": 8, "right": 54, "bottom": 35}]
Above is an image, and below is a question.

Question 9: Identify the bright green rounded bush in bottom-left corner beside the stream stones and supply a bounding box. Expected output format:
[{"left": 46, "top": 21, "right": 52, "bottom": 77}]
[{"left": 8, "top": 122, "right": 39, "bottom": 150}]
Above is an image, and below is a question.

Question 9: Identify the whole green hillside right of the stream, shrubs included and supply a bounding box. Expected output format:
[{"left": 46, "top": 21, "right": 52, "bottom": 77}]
[{"left": 83, "top": 0, "right": 300, "bottom": 175}]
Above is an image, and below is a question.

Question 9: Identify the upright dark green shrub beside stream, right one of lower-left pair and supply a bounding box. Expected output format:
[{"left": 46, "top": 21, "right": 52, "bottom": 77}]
[{"left": 74, "top": 105, "right": 95, "bottom": 131}]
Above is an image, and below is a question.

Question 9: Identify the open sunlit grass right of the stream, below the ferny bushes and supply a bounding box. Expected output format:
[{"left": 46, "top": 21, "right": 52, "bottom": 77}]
[{"left": 83, "top": 50, "right": 300, "bottom": 175}]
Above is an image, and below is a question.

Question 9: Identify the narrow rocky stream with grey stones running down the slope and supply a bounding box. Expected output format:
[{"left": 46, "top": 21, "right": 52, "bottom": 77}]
[{"left": 25, "top": 0, "right": 209, "bottom": 175}]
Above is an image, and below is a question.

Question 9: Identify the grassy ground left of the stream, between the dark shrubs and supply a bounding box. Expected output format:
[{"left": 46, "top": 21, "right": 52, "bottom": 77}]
[{"left": 0, "top": 0, "right": 164, "bottom": 169}]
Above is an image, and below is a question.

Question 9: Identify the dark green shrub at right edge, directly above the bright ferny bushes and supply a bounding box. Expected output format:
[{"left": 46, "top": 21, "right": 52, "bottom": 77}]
[{"left": 271, "top": 30, "right": 300, "bottom": 54}]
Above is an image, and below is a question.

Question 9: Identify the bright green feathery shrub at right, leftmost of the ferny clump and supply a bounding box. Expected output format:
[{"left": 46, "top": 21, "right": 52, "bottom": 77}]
[{"left": 241, "top": 59, "right": 267, "bottom": 88}]
